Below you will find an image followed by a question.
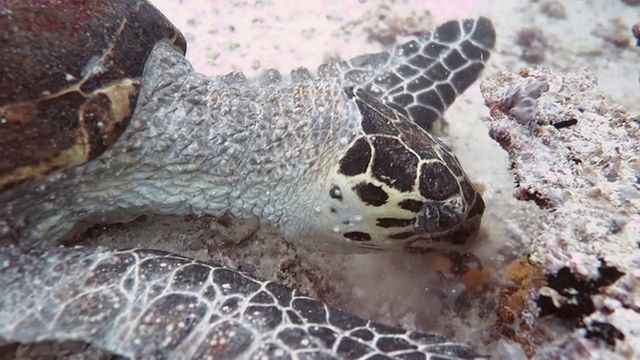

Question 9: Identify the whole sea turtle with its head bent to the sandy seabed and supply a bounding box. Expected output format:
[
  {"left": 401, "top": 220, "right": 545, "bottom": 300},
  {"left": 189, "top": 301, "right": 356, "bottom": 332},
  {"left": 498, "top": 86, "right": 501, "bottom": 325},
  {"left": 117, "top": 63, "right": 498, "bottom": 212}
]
[{"left": 0, "top": 0, "right": 495, "bottom": 359}]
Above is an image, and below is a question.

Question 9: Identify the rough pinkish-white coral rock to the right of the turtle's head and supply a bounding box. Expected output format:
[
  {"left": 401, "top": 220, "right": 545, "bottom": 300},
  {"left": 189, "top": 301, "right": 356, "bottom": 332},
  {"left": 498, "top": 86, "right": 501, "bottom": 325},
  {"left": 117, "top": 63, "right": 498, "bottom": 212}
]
[{"left": 481, "top": 68, "right": 640, "bottom": 358}]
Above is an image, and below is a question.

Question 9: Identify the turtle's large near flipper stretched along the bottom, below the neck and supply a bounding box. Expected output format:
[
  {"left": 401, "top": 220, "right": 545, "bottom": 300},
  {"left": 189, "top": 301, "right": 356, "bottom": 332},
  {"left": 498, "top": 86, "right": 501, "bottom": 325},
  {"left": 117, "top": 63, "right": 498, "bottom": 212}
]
[{"left": 0, "top": 247, "right": 477, "bottom": 360}]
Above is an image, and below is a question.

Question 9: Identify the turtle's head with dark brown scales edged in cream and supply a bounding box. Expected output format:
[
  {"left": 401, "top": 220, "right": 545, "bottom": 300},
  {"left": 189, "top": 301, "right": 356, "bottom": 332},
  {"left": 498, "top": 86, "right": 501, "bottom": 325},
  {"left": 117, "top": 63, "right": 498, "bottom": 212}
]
[{"left": 310, "top": 89, "right": 485, "bottom": 250}]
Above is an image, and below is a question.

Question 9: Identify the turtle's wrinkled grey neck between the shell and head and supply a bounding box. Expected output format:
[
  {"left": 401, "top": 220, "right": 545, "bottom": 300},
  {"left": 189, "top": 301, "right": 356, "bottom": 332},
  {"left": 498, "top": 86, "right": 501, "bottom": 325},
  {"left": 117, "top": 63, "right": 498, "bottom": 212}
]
[{"left": 0, "top": 44, "right": 359, "bottom": 245}]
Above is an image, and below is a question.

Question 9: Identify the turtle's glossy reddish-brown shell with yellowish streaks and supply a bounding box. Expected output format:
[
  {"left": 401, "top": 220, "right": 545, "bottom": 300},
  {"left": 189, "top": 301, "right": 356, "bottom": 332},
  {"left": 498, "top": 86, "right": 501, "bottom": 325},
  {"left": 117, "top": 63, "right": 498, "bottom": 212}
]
[{"left": 0, "top": 0, "right": 186, "bottom": 191}]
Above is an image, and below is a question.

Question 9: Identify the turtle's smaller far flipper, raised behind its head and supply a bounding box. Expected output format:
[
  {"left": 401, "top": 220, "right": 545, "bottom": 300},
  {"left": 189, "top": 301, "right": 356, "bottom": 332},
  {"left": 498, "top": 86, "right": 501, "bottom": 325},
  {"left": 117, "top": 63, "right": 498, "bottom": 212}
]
[{"left": 318, "top": 17, "right": 496, "bottom": 131}]
